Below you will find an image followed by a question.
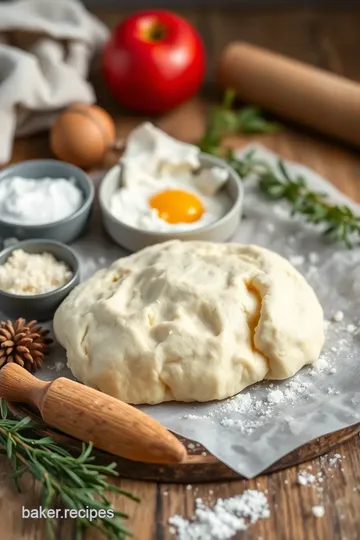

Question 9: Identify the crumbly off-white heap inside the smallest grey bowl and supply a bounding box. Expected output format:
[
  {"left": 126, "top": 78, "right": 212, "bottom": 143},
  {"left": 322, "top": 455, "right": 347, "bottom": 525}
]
[{"left": 0, "top": 249, "right": 73, "bottom": 295}]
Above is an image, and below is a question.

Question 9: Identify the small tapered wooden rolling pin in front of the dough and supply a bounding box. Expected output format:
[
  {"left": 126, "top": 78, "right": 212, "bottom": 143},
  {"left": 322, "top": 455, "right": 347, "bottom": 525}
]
[{"left": 0, "top": 364, "right": 186, "bottom": 463}]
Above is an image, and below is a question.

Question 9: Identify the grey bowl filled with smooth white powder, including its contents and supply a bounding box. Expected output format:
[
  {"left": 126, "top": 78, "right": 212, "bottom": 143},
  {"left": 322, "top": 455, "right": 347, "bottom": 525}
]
[{"left": 0, "top": 160, "right": 95, "bottom": 243}]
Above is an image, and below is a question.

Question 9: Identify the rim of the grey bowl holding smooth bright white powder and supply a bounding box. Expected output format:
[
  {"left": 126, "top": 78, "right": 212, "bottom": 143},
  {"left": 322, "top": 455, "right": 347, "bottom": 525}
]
[{"left": 0, "top": 158, "right": 95, "bottom": 231}]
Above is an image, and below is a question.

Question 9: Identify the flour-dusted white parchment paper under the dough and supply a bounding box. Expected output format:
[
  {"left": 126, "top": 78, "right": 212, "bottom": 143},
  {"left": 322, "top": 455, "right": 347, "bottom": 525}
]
[{"left": 1, "top": 146, "right": 360, "bottom": 478}]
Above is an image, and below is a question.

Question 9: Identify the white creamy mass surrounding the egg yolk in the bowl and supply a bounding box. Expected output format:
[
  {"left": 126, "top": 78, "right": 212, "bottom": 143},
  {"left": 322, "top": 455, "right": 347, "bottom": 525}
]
[{"left": 110, "top": 122, "right": 232, "bottom": 232}]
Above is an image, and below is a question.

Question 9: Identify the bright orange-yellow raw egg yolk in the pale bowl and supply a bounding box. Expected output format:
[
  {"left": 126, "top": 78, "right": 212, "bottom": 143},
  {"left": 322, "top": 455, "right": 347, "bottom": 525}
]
[{"left": 149, "top": 189, "right": 205, "bottom": 224}]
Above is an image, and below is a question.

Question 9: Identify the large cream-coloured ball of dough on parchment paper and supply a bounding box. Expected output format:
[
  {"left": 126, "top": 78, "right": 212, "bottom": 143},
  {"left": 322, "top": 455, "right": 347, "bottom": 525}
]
[{"left": 54, "top": 241, "right": 324, "bottom": 404}]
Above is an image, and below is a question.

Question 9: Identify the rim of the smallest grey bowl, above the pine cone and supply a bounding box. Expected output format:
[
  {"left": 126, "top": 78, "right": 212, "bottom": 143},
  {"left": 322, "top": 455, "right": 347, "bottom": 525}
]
[{"left": 0, "top": 238, "right": 80, "bottom": 302}]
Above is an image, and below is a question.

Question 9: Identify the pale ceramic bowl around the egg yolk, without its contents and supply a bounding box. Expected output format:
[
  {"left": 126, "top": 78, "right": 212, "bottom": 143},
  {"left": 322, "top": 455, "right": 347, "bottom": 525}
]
[{"left": 99, "top": 154, "right": 244, "bottom": 251}]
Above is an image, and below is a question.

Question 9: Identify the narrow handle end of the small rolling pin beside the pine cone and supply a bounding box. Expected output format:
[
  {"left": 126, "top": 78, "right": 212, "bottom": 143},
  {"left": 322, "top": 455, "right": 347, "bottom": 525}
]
[{"left": 0, "top": 363, "right": 52, "bottom": 412}]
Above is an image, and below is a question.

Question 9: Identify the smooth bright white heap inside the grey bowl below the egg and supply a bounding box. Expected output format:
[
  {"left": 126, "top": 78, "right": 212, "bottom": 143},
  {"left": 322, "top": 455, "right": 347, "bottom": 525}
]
[{"left": 0, "top": 176, "right": 83, "bottom": 225}]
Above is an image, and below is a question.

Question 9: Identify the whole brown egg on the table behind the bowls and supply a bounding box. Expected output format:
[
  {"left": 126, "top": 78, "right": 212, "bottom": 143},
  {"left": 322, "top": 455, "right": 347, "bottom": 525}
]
[{"left": 50, "top": 104, "right": 115, "bottom": 169}]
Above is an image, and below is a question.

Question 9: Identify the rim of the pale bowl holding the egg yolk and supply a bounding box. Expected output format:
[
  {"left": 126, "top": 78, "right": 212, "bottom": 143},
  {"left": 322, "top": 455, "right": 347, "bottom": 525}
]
[{"left": 98, "top": 152, "right": 244, "bottom": 239}]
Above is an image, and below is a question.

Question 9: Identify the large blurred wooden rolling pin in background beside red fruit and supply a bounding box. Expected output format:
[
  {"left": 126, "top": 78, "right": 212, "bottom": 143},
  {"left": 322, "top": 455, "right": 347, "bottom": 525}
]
[{"left": 219, "top": 43, "right": 360, "bottom": 145}]
